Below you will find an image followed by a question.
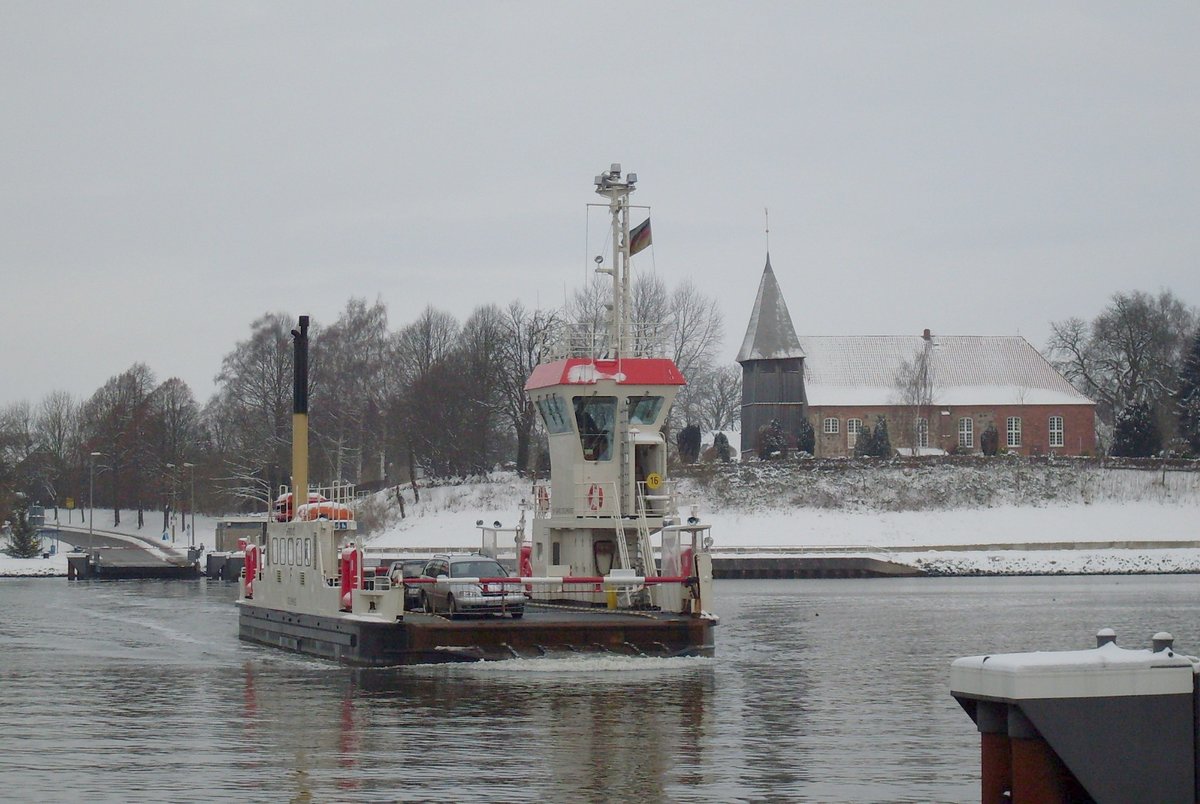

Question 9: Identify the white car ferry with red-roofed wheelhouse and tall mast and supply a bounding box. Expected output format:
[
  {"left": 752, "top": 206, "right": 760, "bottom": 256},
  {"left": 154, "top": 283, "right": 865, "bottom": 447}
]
[{"left": 238, "top": 164, "right": 719, "bottom": 666}]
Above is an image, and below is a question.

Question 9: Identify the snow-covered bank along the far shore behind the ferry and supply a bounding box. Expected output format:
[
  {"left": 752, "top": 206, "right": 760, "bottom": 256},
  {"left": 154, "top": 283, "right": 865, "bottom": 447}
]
[{"left": 0, "top": 470, "right": 1200, "bottom": 575}]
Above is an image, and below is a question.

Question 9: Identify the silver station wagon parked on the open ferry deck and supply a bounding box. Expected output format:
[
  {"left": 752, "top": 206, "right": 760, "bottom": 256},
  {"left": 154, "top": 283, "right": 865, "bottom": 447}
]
[{"left": 420, "top": 554, "right": 526, "bottom": 619}]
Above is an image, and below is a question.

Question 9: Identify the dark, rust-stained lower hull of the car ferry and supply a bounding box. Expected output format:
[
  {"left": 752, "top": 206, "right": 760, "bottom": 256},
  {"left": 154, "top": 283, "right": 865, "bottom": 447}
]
[{"left": 239, "top": 601, "right": 714, "bottom": 667}]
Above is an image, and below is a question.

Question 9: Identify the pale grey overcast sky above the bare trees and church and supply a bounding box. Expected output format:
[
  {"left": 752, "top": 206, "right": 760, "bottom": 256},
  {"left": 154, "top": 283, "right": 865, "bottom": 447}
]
[{"left": 0, "top": 0, "right": 1200, "bottom": 404}]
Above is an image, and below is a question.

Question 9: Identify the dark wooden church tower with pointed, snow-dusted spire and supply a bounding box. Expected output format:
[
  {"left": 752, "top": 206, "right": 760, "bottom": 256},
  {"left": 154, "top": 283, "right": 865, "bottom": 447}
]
[{"left": 738, "top": 254, "right": 806, "bottom": 454}]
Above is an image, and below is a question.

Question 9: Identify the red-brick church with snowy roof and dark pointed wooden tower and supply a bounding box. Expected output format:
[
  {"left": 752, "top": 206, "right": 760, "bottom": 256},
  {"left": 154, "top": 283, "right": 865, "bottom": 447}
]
[{"left": 737, "top": 256, "right": 1096, "bottom": 457}]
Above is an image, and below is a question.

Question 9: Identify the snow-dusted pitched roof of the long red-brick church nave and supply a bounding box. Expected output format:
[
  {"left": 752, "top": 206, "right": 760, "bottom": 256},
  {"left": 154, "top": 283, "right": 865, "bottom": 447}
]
[{"left": 798, "top": 335, "right": 1094, "bottom": 406}]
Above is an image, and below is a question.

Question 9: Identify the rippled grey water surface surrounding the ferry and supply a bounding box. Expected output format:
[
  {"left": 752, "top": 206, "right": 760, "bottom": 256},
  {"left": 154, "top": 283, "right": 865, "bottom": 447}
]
[{"left": 0, "top": 577, "right": 1200, "bottom": 802}]
